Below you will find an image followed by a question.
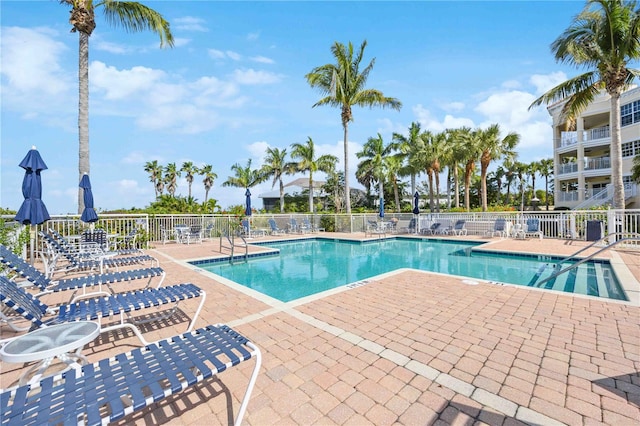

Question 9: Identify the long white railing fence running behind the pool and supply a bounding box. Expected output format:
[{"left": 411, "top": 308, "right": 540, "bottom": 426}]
[{"left": 3, "top": 209, "right": 640, "bottom": 262}]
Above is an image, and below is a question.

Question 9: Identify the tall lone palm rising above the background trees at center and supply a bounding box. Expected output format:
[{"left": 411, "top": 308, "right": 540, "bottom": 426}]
[{"left": 305, "top": 40, "right": 402, "bottom": 213}]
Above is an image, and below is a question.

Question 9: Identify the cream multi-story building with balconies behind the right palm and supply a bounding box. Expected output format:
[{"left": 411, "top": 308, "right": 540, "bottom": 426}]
[{"left": 548, "top": 87, "right": 640, "bottom": 209}]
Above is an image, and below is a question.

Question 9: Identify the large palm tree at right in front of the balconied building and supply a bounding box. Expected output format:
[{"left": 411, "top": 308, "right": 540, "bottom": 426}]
[{"left": 529, "top": 0, "right": 640, "bottom": 209}]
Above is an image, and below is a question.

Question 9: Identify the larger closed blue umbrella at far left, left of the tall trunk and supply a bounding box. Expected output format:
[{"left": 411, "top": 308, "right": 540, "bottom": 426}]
[{"left": 15, "top": 146, "right": 51, "bottom": 225}]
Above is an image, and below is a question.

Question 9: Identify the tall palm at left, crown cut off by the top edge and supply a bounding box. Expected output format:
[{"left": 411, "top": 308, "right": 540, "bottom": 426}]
[{"left": 60, "top": 0, "right": 173, "bottom": 213}]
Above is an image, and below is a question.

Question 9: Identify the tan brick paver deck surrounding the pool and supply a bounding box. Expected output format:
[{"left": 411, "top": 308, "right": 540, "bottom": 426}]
[{"left": 0, "top": 233, "right": 640, "bottom": 425}]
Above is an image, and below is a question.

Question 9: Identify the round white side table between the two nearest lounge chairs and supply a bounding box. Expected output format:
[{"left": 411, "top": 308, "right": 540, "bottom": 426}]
[{"left": 0, "top": 321, "right": 100, "bottom": 385}]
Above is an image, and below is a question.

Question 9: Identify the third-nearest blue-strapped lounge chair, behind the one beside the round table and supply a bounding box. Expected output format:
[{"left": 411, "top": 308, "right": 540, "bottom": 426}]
[{"left": 0, "top": 244, "right": 165, "bottom": 302}]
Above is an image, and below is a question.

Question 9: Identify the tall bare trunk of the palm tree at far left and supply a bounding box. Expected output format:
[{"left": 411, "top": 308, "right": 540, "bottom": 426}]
[{"left": 78, "top": 31, "right": 89, "bottom": 214}]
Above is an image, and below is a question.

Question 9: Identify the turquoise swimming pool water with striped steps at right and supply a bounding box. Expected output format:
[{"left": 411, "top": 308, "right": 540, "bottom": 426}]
[{"left": 192, "top": 238, "right": 626, "bottom": 302}]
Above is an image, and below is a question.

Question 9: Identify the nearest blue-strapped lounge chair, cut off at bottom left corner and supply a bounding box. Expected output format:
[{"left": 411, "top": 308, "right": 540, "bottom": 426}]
[{"left": 0, "top": 324, "right": 262, "bottom": 425}]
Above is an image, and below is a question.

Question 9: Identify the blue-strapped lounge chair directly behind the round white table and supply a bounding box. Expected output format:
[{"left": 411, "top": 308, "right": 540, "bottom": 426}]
[{"left": 0, "top": 276, "right": 206, "bottom": 345}]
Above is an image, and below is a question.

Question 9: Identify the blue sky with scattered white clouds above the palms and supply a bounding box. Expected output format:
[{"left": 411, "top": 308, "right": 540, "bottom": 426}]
[{"left": 0, "top": 0, "right": 584, "bottom": 214}]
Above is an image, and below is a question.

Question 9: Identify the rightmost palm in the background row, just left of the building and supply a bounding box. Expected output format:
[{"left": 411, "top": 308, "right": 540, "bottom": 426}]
[{"left": 478, "top": 124, "right": 520, "bottom": 212}]
